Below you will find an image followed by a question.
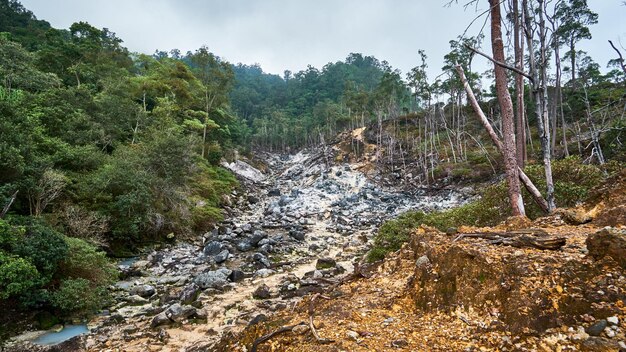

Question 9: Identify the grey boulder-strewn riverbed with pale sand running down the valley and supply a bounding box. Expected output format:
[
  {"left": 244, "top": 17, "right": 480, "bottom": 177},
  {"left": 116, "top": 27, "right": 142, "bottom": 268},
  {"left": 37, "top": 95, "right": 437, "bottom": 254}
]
[{"left": 6, "top": 152, "right": 467, "bottom": 351}]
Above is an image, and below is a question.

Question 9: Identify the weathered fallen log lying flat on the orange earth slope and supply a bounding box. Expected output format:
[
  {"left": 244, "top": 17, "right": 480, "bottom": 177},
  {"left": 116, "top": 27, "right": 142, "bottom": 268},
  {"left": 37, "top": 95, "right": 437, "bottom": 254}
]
[{"left": 454, "top": 229, "right": 566, "bottom": 250}]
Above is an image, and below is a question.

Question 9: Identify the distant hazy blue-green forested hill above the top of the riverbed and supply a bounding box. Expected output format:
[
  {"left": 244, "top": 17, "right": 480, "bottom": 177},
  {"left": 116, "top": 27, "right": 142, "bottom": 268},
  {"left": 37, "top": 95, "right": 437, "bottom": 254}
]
[{"left": 230, "top": 53, "right": 412, "bottom": 150}]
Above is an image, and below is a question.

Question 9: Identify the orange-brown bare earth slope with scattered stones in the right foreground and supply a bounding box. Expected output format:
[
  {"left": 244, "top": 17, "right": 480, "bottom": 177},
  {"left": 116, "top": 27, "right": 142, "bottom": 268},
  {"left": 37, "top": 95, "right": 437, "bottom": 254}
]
[{"left": 213, "top": 172, "right": 626, "bottom": 351}]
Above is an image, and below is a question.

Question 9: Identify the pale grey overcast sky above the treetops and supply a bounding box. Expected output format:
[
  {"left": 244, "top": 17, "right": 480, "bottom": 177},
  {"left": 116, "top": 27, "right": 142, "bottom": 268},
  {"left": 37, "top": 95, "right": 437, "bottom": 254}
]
[{"left": 21, "top": 0, "right": 626, "bottom": 78}]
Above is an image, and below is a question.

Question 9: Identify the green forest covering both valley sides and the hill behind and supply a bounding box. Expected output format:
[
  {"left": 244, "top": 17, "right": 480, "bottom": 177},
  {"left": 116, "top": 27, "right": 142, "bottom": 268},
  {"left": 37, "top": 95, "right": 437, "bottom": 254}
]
[{"left": 0, "top": 0, "right": 626, "bottom": 346}]
